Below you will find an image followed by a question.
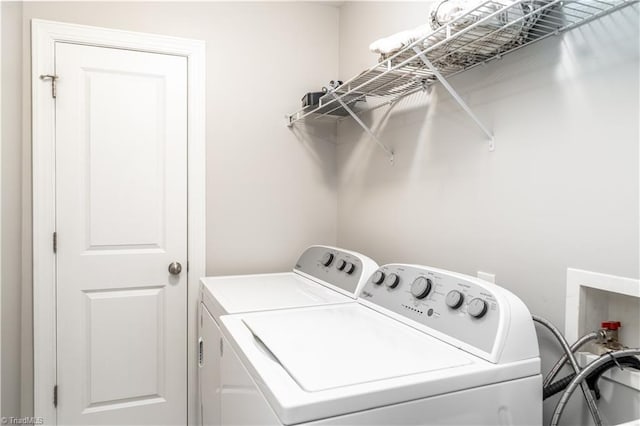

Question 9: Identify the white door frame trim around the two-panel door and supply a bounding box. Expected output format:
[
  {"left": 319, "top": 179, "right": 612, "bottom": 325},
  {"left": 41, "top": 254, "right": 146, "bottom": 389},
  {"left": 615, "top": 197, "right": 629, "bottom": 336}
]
[{"left": 31, "top": 19, "right": 206, "bottom": 424}]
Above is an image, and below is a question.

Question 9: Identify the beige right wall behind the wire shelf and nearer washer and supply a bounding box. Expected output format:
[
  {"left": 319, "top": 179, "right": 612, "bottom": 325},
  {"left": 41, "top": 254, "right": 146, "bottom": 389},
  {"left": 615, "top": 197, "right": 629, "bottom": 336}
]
[{"left": 337, "top": 2, "right": 640, "bottom": 420}]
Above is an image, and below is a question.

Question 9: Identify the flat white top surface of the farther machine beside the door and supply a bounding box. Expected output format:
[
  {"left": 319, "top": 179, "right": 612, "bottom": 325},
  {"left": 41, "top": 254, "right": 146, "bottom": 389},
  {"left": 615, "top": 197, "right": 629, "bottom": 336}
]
[{"left": 201, "top": 272, "right": 353, "bottom": 316}]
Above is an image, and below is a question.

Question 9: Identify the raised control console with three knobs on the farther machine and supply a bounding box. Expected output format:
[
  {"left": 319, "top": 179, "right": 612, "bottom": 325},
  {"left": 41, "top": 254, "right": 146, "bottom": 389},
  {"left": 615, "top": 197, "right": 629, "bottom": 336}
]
[{"left": 294, "top": 246, "right": 378, "bottom": 297}]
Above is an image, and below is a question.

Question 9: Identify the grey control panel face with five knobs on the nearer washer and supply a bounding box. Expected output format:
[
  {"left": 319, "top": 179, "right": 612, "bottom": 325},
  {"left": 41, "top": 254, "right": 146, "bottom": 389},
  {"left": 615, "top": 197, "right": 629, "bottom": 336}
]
[{"left": 360, "top": 264, "right": 500, "bottom": 353}]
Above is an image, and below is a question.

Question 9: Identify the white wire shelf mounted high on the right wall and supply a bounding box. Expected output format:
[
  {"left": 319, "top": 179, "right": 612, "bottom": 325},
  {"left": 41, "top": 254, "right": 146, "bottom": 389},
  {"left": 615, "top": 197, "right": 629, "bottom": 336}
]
[{"left": 287, "top": 0, "right": 639, "bottom": 125}]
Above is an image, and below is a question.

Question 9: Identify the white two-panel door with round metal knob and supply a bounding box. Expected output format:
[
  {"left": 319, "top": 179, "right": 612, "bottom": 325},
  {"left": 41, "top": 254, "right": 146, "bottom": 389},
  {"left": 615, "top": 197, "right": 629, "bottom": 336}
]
[{"left": 55, "top": 42, "right": 187, "bottom": 425}]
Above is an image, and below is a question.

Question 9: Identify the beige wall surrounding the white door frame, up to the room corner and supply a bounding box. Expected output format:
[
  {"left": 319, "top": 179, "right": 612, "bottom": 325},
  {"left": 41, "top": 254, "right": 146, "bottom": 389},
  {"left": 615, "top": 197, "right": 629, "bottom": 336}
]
[{"left": 2, "top": 2, "right": 339, "bottom": 416}]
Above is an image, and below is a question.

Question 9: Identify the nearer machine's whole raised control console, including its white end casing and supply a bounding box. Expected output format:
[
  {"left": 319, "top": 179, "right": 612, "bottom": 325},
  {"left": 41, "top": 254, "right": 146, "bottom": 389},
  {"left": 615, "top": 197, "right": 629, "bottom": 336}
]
[{"left": 360, "top": 264, "right": 538, "bottom": 362}]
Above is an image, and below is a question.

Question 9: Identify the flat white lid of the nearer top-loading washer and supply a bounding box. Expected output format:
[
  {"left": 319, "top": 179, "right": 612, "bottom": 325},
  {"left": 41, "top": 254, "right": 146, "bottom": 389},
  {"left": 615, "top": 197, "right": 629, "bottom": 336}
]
[{"left": 243, "top": 305, "right": 474, "bottom": 392}]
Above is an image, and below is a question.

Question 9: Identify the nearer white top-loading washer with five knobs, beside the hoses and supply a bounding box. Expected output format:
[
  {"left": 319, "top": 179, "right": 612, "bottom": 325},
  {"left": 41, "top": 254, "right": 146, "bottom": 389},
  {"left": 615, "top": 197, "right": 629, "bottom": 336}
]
[{"left": 218, "top": 264, "right": 542, "bottom": 426}]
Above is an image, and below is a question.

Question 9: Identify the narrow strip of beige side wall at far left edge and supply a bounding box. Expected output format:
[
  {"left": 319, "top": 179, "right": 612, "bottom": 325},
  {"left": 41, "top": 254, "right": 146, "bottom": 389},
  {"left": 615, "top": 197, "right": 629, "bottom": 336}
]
[{"left": 0, "top": 3, "right": 23, "bottom": 416}]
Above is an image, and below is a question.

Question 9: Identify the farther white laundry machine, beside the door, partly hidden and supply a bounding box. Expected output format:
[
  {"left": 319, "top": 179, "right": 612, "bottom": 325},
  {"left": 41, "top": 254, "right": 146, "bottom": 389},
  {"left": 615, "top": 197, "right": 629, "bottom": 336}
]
[{"left": 198, "top": 246, "right": 378, "bottom": 426}]
